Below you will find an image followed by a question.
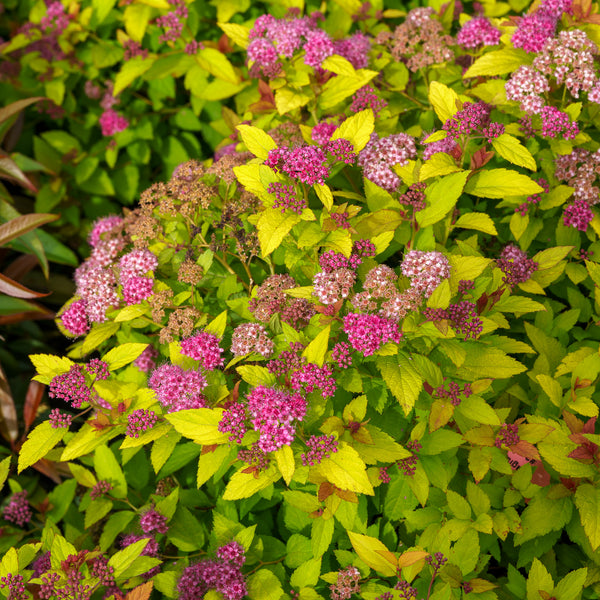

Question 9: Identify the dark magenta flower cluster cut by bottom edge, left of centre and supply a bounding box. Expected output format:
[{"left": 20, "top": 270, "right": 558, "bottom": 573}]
[{"left": 177, "top": 542, "right": 248, "bottom": 600}]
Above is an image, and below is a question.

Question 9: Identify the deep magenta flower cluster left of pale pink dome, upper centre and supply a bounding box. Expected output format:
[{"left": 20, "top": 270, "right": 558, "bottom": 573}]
[{"left": 265, "top": 146, "right": 329, "bottom": 185}]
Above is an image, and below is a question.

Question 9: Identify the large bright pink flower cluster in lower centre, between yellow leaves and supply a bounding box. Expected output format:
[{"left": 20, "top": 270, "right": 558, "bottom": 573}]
[{"left": 248, "top": 385, "right": 306, "bottom": 452}]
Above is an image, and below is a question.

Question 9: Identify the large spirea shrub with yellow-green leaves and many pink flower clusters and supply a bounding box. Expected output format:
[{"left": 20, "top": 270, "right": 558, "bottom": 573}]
[{"left": 0, "top": 0, "right": 600, "bottom": 600}]
